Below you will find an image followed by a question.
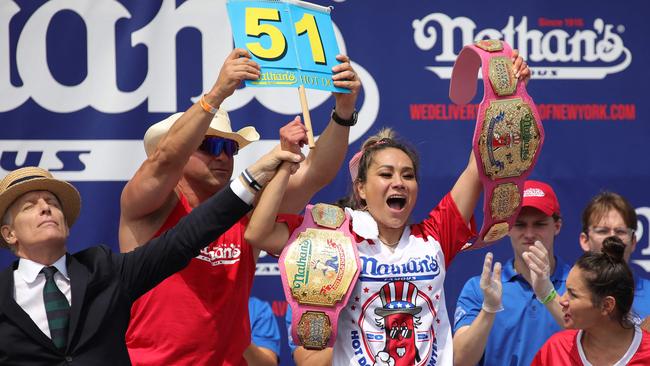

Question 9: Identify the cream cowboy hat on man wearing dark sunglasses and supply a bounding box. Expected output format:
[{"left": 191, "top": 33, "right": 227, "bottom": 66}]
[{"left": 144, "top": 109, "right": 260, "bottom": 156}]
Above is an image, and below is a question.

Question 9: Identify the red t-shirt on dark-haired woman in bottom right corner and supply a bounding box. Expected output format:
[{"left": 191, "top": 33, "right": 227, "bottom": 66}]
[{"left": 531, "top": 328, "right": 650, "bottom": 366}]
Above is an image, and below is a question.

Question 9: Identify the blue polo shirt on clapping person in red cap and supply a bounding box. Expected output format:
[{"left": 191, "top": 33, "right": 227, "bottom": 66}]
[{"left": 454, "top": 257, "right": 571, "bottom": 366}]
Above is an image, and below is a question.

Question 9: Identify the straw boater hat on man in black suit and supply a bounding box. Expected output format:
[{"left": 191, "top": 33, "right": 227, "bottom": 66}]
[{"left": 0, "top": 166, "right": 81, "bottom": 247}]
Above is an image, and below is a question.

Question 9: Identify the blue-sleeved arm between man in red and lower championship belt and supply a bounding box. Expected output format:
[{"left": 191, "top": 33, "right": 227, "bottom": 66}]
[{"left": 244, "top": 296, "right": 280, "bottom": 366}]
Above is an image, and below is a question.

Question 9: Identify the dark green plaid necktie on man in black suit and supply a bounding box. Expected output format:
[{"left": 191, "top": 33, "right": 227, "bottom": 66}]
[{"left": 41, "top": 267, "right": 70, "bottom": 349}]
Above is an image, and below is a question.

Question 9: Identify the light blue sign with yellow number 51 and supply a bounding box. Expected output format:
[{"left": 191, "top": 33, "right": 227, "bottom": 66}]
[{"left": 227, "top": 0, "right": 350, "bottom": 93}]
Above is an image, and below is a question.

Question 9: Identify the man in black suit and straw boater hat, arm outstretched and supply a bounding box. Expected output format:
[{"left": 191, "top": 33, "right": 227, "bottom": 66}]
[{"left": 0, "top": 140, "right": 302, "bottom": 365}]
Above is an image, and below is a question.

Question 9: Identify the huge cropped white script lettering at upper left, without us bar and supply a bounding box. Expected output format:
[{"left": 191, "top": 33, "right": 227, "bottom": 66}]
[{"left": 0, "top": 0, "right": 379, "bottom": 142}]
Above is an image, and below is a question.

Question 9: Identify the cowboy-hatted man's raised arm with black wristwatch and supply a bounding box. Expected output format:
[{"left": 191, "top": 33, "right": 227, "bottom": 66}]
[{"left": 280, "top": 55, "right": 361, "bottom": 213}]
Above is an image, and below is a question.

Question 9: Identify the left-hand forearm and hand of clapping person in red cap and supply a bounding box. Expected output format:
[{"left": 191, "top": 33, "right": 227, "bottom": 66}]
[{"left": 454, "top": 253, "right": 503, "bottom": 366}]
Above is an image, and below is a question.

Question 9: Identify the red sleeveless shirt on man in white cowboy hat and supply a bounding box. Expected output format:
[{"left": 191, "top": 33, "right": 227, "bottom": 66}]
[{"left": 126, "top": 196, "right": 298, "bottom": 366}]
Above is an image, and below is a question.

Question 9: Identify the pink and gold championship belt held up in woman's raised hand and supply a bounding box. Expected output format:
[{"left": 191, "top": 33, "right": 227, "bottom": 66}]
[{"left": 449, "top": 40, "right": 544, "bottom": 249}]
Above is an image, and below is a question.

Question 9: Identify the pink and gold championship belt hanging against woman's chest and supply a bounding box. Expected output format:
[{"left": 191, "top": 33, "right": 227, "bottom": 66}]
[{"left": 279, "top": 203, "right": 361, "bottom": 350}]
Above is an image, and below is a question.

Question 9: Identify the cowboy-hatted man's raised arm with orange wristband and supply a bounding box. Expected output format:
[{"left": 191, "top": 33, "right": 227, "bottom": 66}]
[{"left": 120, "top": 49, "right": 259, "bottom": 252}]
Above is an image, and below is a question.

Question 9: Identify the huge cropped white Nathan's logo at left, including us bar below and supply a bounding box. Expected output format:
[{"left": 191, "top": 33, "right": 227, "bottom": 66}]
[{"left": 0, "top": 0, "right": 380, "bottom": 182}]
